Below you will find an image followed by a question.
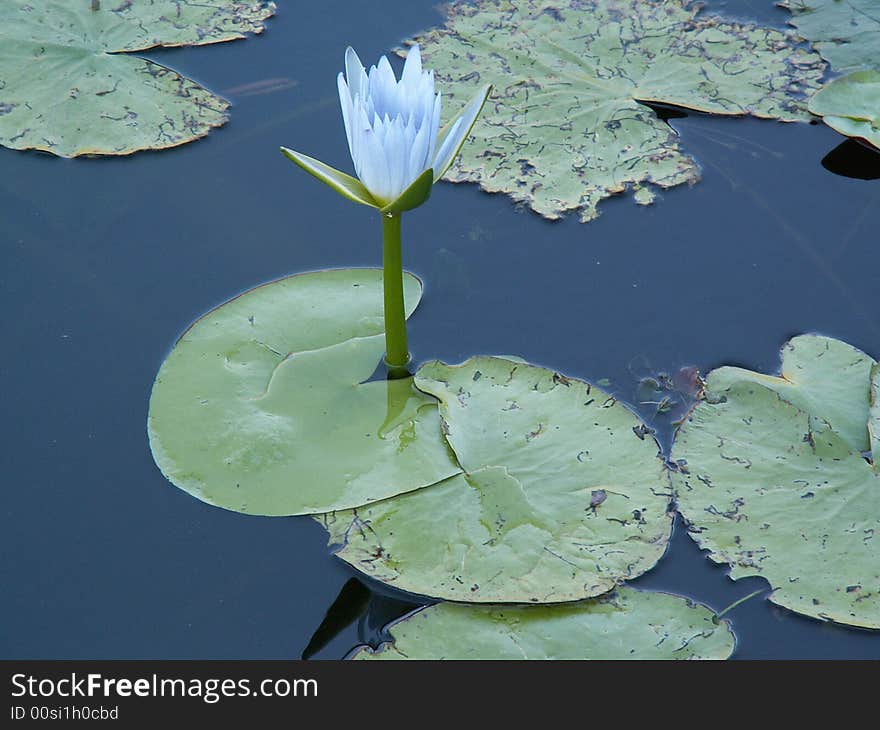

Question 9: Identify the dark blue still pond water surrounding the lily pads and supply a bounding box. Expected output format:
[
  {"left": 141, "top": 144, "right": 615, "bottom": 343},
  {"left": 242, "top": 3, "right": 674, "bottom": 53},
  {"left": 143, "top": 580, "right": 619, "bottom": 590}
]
[{"left": 0, "top": 0, "right": 880, "bottom": 659}]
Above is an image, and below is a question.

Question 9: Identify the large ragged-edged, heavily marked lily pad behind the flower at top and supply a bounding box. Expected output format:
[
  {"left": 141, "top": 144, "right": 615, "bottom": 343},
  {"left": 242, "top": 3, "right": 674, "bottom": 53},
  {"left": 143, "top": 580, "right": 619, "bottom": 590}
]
[{"left": 406, "top": 0, "right": 824, "bottom": 221}]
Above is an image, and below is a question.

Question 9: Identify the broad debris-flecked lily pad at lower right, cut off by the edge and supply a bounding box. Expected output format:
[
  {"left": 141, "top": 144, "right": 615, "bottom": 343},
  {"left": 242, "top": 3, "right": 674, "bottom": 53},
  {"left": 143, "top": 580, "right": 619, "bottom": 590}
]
[{"left": 673, "top": 338, "right": 880, "bottom": 628}]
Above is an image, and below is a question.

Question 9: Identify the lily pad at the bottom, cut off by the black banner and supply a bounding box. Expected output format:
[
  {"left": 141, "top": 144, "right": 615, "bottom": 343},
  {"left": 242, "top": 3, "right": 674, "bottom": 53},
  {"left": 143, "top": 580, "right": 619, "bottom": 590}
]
[{"left": 351, "top": 588, "right": 735, "bottom": 659}]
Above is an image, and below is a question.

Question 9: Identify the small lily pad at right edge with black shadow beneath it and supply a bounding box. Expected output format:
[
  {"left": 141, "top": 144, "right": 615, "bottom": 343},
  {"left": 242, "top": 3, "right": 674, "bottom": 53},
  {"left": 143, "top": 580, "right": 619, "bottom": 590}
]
[{"left": 810, "top": 71, "right": 880, "bottom": 149}]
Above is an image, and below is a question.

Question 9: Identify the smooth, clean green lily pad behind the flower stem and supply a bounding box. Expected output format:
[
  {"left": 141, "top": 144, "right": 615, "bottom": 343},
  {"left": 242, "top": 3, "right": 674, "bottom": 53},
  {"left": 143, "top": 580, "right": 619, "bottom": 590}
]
[{"left": 149, "top": 269, "right": 460, "bottom": 515}]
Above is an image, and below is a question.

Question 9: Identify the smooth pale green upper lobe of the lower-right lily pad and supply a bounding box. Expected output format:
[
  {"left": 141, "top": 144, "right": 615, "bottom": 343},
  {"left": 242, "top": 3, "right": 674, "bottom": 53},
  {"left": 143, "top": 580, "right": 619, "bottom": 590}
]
[{"left": 706, "top": 335, "right": 874, "bottom": 451}]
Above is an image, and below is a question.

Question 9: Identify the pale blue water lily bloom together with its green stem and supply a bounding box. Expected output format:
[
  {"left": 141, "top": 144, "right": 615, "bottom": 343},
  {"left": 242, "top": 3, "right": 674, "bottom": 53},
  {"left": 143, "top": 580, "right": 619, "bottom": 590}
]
[{"left": 281, "top": 45, "right": 491, "bottom": 370}]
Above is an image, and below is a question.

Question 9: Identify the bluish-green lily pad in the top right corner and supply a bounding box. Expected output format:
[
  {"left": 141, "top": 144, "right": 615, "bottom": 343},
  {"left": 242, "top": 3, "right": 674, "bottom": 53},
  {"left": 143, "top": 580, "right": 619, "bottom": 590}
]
[{"left": 778, "top": 0, "right": 880, "bottom": 73}]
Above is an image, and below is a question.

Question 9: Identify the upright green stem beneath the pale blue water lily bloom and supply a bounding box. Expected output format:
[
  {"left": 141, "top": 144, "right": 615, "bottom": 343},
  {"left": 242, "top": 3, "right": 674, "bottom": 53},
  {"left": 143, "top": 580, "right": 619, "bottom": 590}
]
[{"left": 382, "top": 213, "right": 410, "bottom": 378}]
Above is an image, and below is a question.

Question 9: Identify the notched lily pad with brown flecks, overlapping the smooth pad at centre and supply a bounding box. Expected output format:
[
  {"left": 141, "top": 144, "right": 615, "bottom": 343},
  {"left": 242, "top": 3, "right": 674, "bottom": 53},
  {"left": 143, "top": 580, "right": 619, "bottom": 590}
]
[{"left": 320, "top": 357, "right": 671, "bottom": 603}]
